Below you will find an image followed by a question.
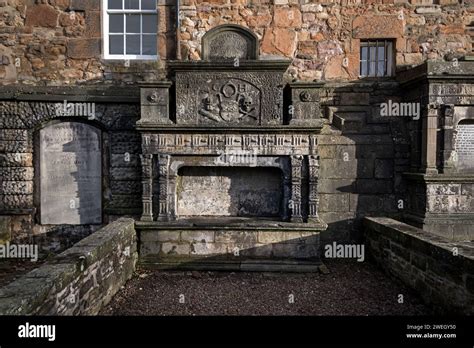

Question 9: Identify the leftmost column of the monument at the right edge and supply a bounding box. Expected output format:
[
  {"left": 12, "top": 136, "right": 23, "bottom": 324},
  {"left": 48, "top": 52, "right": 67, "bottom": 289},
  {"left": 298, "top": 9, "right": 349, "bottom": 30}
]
[{"left": 421, "top": 103, "right": 439, "bottom": 174}]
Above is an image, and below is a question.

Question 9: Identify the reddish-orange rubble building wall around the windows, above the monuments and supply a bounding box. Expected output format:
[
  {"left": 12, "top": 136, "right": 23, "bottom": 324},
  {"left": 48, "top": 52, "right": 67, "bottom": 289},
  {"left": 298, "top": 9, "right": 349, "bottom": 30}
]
[{"left": 0, "top": 0, "right": 473, "bottom": 85}]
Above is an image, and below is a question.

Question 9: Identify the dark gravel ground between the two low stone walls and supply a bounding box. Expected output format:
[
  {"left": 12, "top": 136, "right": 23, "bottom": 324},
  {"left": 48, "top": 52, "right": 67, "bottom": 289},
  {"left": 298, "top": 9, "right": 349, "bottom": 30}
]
[{"left": 101, "top": 260, "right": 430, "bottom": 315}]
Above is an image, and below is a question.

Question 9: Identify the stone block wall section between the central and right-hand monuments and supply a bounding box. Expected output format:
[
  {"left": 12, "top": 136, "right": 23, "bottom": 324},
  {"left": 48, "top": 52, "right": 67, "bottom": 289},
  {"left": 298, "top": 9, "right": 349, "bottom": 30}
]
[{"left": 318, "top": 80, "right": 412, "bottom": 246}]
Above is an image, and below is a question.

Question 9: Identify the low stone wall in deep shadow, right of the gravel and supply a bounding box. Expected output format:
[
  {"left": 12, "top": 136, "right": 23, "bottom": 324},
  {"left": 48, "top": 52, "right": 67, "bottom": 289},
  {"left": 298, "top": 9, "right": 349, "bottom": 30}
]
[{"left": 364, "top": 218, "right": 474, "bottom": 315}]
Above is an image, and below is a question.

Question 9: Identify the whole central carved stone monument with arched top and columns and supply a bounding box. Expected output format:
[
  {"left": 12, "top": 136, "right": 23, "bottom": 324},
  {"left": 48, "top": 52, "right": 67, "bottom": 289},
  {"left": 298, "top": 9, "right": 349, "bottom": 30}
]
[{"left": 133, "top": 25, "right": 326, "bottom": 268}]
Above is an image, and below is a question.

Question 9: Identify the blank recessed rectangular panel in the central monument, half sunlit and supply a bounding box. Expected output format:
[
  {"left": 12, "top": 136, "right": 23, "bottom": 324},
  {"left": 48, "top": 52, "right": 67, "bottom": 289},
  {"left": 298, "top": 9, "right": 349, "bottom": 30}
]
[{"left": 177, "top": 167, "right": 282, "bottom": 217}]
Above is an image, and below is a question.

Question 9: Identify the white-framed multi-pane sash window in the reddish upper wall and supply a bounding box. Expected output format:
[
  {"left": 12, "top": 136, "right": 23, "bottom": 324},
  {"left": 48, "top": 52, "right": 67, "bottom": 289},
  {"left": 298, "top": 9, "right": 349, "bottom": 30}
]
[{"left": 102, "top": 0, "right": 159, "bottom": 60}]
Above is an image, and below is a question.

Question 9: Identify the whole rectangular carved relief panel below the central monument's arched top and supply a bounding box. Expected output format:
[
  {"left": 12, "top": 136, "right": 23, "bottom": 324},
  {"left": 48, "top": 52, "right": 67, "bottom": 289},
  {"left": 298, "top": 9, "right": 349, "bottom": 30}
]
[{"left": 176, "top": 71, "right": 283, "bottom": 126}]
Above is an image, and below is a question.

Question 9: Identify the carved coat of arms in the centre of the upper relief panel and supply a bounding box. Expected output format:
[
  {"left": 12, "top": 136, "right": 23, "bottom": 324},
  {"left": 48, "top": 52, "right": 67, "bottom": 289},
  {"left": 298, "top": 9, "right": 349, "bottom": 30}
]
[{"left": 199, "top": 79, "right": 260, "bottom": 123}]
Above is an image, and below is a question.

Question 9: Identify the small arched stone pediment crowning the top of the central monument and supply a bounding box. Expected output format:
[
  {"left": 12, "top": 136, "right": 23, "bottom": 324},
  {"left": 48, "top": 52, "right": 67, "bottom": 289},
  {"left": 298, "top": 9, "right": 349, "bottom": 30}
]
[{"left": 202, "top": 24, "right": 259, "bottom": 60}]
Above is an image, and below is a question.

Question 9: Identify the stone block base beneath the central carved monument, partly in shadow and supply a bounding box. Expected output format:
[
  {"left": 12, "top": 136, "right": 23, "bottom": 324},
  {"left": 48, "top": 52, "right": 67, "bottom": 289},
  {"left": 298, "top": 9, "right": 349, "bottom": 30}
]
[{"left": 136, "top": 222, "right": 320, "bottom": 271}]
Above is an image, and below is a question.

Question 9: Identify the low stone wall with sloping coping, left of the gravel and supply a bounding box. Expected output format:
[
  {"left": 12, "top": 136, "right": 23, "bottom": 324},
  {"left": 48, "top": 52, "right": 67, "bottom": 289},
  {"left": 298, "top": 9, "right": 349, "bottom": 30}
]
[{"left": 0, "top": 218, "right": 137, "bottom": 315}]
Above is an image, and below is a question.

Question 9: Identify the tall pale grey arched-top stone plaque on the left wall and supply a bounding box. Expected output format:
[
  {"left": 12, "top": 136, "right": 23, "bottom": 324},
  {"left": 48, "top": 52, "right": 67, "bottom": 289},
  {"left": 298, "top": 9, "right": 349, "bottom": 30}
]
[{"left": 39, "top": 122, "right": 102, "bottom": 225}]
